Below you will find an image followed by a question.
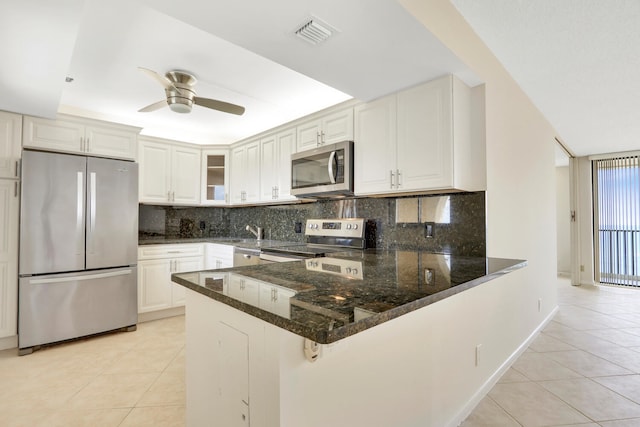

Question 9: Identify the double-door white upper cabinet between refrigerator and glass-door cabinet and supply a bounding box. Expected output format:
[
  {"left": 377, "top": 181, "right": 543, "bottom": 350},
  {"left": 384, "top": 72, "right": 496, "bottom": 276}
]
[{"left": 138, "top": 138, "right": 201, "bottom": 205}]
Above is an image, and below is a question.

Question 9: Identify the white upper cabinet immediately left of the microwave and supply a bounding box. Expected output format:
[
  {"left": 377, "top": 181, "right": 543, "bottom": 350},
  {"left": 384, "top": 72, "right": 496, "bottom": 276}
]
[{"left": 260, "top": 128, "right": 296, "bottom": 202}]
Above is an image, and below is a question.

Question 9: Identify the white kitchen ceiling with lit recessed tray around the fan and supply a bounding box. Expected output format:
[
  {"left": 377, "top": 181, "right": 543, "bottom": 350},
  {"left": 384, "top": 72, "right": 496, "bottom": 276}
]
[{"left": 0, "top": 0, "right": 480, "bottom": 144}]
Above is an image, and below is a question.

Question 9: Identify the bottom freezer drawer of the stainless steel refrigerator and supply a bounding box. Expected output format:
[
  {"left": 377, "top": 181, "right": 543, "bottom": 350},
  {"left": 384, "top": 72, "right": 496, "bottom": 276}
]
[{"left": 18, "top": 267, "right": 138, "bottom": 349}]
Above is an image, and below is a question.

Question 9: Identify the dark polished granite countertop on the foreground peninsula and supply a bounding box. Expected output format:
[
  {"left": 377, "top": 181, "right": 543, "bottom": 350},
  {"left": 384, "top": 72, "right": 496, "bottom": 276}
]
[{"left": 172, "top": 249, "right": 527, "bottom": 344}]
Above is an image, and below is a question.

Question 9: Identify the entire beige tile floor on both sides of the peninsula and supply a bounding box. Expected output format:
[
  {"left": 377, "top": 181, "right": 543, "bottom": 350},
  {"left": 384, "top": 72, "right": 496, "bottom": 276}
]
[{"left": 0, "top": 280, "right": 640, "bottom": 427}]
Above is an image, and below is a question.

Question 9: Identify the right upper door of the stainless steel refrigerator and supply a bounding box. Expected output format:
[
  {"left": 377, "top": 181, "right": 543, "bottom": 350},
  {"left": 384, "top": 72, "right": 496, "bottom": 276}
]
[{"left": 86, "top": 157, "right": 138, "bottom": 269}]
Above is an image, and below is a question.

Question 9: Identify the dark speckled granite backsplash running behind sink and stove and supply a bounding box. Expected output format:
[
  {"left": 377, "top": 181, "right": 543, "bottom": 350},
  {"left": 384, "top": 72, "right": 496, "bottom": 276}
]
[{"left": 139, "top": 191, "right": 486, "bottom": 257}]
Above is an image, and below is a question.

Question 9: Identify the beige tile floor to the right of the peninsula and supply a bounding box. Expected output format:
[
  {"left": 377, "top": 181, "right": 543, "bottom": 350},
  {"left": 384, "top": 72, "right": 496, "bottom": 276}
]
[{"left": 462, "top": 279, "right": 640, "bottom": 427}]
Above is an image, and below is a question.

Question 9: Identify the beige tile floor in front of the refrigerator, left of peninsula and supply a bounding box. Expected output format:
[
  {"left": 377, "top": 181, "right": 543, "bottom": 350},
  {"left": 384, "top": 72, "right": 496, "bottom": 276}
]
[{"left": 0, "top": 316, "right": 185, "bottom": 427}]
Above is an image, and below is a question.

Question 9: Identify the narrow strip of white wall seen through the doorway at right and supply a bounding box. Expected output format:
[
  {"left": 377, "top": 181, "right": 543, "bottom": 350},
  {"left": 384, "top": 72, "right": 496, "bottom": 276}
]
[{"left": 556, "top": 166, "right": 571, "bottom": 277}]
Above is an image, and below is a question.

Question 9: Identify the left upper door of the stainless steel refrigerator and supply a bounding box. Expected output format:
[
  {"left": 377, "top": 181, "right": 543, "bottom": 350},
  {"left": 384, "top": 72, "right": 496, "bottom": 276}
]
[{"left": 20, "top": 150, "right": 86, "bottom": 275}]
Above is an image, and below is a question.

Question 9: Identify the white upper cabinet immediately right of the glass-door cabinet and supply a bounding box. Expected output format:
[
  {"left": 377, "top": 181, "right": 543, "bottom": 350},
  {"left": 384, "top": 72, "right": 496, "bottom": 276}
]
[{"left": 230, "top": 139, "right": 260, "bottom": 204}]
